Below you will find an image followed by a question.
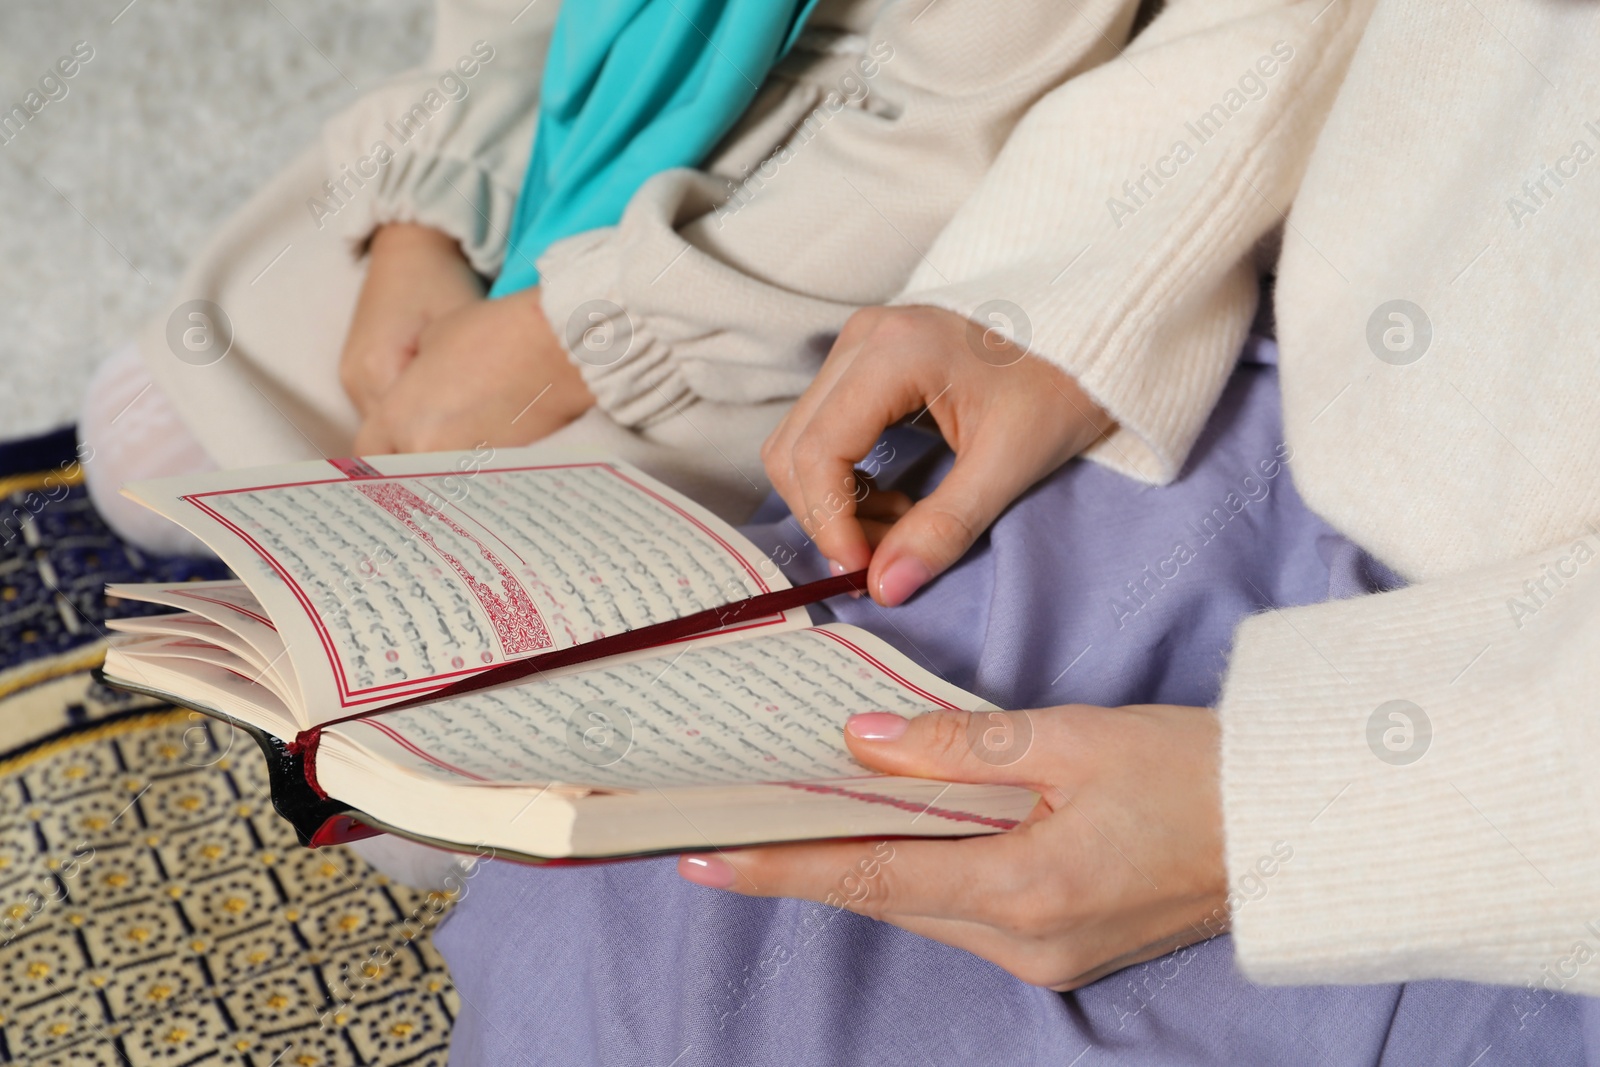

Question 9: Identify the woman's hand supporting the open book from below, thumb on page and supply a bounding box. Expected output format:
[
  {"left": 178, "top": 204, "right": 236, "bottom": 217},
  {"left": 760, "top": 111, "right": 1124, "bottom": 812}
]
[{"left": 678, "top": 705, "right": 1227, "bottom": 989}]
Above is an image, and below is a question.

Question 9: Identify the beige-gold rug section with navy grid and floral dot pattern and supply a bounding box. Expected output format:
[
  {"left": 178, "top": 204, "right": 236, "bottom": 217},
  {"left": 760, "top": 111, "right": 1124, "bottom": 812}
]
[{"left": 0, "top": 699, "right": 458, "bottom": 1067}]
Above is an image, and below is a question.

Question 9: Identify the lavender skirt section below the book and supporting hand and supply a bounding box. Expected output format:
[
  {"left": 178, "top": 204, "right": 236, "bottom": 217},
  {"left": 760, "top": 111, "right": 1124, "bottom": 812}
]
[{"left": 438, "top": 859, "right": 1584, "bottom": 1067}]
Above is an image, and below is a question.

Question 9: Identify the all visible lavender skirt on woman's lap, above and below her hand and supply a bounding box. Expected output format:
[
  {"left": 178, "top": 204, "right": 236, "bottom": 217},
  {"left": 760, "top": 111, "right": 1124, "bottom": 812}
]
[{"left": 438, "top": 347, "right": 1584, "bottom": 1067}]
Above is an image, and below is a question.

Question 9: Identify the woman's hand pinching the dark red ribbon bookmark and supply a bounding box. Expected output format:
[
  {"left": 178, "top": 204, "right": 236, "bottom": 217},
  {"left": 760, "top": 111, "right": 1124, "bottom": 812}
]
[{"left": 762, "top": 307, "right": 1112, "bottom": 605}]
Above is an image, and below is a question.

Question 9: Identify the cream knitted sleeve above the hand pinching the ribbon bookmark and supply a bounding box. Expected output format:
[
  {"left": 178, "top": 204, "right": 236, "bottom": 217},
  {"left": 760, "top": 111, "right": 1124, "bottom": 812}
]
[{"left": 896, "top": 0, "right": 1373, "bottom": 483}]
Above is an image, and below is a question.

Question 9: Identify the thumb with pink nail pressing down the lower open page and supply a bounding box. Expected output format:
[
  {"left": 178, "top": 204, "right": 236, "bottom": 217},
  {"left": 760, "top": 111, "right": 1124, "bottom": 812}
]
[{"left": 845, "top": 710, "right": 1038, "bottom": 785}]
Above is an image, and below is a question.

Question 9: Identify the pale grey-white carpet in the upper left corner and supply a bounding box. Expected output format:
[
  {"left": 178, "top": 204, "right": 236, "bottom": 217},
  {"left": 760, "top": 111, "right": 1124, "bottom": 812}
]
[{"left": 0, "top": 0, "right": 432, "bottom": 438}]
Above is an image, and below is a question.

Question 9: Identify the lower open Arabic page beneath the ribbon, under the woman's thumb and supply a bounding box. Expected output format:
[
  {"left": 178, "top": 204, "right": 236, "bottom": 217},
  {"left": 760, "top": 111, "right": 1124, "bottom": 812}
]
[{"left": 320, "top": 624, "right": 994, "bottom": 803}]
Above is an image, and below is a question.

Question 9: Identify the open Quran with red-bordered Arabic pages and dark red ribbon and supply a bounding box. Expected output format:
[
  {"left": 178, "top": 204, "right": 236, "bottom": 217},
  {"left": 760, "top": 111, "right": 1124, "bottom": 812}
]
[{"left": 104, "top": 450, "right": 1035, "bottom": 861}]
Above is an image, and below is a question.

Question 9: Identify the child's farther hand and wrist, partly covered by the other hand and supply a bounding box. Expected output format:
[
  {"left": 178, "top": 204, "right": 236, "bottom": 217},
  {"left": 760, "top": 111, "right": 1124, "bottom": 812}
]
[{"left": 339, "top": 222, "right": 483, "bottom": 418}]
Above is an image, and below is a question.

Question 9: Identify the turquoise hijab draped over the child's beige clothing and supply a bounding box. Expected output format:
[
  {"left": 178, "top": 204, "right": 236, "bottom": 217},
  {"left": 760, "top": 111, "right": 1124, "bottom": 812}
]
[{"left": 490, "top": 0, "right": 816, "bottom": 296}]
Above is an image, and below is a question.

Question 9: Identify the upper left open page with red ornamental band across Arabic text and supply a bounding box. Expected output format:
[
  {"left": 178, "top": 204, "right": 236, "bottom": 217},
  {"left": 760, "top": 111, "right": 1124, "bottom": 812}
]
[{"left": 128, "top": 450, "right": 808, "bottom": 723}]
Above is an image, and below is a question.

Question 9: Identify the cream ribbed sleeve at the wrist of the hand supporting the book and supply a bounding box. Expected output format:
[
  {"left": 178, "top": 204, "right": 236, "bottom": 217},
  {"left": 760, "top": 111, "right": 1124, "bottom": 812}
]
[{"left": 1219, "top": 560, "right": 1600, "bottom": 993}]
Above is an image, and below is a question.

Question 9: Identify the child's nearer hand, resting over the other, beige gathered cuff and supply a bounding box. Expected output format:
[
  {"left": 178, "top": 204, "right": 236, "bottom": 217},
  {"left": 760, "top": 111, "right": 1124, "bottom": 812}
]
[{"left": 355, "top": 290, "right": 595, "bottom": 456}]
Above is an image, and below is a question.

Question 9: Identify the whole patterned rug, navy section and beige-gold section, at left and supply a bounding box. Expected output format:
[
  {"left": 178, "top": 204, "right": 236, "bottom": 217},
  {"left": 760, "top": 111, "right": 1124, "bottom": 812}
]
[{"left": 0, "top": 435, "right": 458, "bottom": 1067}]
